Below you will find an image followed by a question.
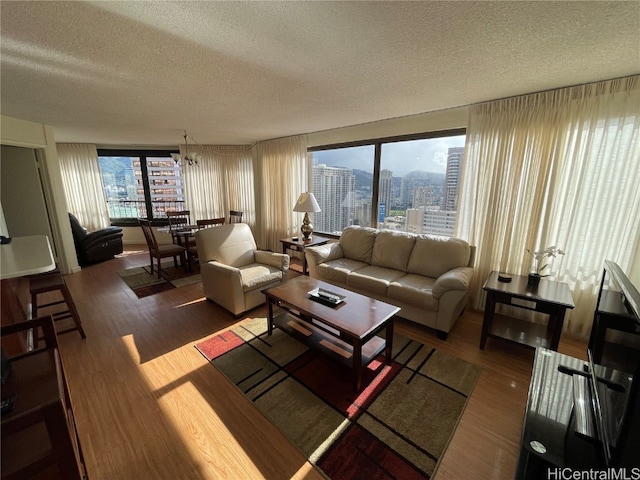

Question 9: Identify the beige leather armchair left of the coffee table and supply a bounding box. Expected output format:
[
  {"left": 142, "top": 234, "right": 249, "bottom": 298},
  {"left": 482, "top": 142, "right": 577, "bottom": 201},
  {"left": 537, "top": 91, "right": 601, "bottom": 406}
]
[{"left": 195, "top": 223, "right": 289, "bottom": 316}]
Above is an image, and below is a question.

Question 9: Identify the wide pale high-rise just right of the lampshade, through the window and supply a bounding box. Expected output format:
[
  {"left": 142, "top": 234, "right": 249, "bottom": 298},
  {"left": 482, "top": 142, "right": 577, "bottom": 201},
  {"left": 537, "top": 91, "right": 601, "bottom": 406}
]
[{"left": 312, "top": 164, "right": 358, "bottom": 233}]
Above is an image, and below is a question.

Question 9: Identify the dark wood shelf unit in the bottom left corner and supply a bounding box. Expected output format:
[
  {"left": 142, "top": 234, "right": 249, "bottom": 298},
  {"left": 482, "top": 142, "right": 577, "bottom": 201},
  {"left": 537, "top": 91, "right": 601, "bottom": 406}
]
[{"left": 1, "top": 316, "right": 87, "bottom": 480}]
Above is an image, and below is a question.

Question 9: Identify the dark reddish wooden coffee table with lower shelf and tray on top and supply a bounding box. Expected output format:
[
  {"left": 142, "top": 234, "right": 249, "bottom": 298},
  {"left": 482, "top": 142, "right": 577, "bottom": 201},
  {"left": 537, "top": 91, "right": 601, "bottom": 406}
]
[{"left": 263, "top": 276, "right": 400, "bottom": 391}]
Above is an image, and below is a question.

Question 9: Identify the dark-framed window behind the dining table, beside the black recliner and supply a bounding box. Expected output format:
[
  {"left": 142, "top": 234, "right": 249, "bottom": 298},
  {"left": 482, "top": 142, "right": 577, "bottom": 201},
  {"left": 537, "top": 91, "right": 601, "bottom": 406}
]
[{"left": 98, "top": 150, "right": 184, "bottom": 225}]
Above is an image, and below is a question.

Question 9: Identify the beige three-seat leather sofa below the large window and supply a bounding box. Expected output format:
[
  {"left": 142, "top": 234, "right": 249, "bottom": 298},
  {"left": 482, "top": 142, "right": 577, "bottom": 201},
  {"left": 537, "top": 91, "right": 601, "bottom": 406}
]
[{"left": 305, "top": 227, "right": 475, "bottom": 339}]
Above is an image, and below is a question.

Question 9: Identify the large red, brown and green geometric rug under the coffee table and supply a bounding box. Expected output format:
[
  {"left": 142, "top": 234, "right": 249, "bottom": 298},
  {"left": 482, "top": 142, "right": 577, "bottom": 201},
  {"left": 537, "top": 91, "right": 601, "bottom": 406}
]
[{"left": 196, "top": 318, "right": 480, "bottom": 480}]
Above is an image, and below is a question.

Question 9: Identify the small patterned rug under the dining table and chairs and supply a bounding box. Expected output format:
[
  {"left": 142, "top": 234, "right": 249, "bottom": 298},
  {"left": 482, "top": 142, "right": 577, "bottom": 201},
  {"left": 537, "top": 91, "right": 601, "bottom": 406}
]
[{"left": 118, "top": 262, "right": 202, "bottom": 298}]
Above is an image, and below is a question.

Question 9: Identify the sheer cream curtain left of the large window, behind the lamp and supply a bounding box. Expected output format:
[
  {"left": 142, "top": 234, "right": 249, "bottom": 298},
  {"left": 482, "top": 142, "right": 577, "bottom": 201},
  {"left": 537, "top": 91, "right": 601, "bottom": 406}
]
[{"left": 254, "top": 135, "right": 309, "bottom": 252}]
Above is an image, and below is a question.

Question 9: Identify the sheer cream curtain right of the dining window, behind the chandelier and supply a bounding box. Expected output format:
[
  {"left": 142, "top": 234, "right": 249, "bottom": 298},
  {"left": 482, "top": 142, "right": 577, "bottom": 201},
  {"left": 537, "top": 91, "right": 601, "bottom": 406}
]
[{"left": 181, "top": 145, "right": 255, "bottom": 225}]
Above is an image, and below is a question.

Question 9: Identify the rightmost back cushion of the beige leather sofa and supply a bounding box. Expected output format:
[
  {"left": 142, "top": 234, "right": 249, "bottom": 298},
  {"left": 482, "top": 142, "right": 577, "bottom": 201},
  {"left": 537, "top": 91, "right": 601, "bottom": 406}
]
[{"left": 407, "top": 235, "right": 471, "bottom": 278}]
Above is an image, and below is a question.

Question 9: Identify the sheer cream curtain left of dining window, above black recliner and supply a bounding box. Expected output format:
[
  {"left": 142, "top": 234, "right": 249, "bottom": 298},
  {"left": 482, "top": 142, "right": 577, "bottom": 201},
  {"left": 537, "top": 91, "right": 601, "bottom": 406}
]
[{"left": 56, "top": 143, "right": 111, "bottom": 231}]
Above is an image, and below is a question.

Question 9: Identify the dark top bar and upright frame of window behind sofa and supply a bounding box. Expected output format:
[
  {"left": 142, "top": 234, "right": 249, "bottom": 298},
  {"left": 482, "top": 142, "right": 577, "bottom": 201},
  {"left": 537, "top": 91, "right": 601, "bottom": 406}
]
[{"left": 307, "top": 127, "right": 467, "bottom": 232}]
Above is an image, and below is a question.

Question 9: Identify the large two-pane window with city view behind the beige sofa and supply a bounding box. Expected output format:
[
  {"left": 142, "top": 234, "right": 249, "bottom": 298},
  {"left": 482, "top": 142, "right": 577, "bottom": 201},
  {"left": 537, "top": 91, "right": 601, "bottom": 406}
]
[{"left": 310, "top": 130, "right": 465, "bottom": 236}]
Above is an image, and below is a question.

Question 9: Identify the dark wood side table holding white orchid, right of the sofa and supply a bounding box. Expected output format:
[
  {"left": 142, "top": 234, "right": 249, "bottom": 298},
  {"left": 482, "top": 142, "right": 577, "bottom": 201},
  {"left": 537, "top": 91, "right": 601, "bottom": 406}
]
[{"left": 480, "top": 271, "right": 574, "bottom": 351}]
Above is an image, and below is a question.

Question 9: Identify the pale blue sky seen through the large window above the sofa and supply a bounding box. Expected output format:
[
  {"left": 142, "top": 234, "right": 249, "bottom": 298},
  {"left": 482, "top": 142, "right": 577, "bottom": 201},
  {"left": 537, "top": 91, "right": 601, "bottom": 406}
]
[{"left": 314, "top": 135, "right": 465, "bottom": 177}]
